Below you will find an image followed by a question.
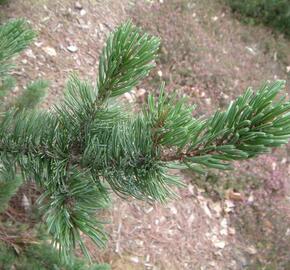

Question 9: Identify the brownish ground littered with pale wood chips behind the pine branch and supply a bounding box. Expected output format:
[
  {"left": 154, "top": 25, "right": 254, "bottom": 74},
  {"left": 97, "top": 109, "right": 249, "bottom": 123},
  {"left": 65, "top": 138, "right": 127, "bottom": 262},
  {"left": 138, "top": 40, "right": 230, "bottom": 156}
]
[{"left": 0, "top": 0, "right": 290, "bottom": 270}]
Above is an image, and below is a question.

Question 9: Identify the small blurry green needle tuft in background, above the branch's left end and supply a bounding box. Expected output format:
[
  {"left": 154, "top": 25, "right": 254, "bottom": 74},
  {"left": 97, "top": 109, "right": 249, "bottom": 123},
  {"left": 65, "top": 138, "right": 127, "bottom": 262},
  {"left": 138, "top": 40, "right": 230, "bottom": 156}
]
[{"left": 14, "top": 80, "right": 49, "bottom": 110}]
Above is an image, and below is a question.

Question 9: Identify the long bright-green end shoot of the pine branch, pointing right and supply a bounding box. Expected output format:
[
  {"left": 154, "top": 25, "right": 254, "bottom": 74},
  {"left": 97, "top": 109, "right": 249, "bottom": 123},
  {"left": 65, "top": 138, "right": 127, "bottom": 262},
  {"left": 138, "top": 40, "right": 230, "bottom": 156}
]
[{"left": 152, "top": 81, "right": 290, "bottom": 171}]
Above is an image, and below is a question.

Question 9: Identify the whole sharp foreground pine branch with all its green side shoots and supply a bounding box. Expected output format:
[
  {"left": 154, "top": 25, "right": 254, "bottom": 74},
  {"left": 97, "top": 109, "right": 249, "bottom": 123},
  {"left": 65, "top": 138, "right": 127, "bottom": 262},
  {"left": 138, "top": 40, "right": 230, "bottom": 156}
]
[{"left": 0, "top": 18, "right": 290, "bottom": 261}]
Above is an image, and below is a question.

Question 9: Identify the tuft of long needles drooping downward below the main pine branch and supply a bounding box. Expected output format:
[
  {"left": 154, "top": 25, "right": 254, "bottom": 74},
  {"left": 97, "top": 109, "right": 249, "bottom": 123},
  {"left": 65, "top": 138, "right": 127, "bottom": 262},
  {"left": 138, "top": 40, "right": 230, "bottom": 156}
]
[{"left": 40, "top": 169, "right": 108, "bottom": 260}]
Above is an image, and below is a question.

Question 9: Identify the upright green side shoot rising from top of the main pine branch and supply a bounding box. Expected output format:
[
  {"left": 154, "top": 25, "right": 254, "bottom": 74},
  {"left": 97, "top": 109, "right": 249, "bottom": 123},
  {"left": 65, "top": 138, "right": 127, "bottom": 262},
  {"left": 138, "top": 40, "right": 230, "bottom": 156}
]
[{"left": 98, "top": 22, "right": 160, "bottom": 99}]
